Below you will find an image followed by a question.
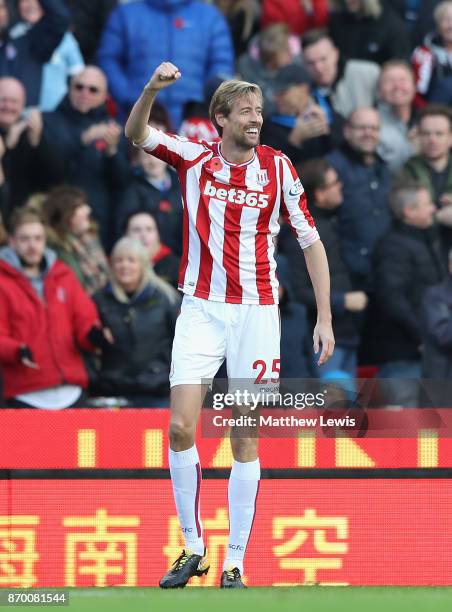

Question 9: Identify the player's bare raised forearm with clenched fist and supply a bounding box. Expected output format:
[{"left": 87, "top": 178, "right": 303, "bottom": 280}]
[{"left": 125, "top": 62, "right": 181, "bottom": 146}]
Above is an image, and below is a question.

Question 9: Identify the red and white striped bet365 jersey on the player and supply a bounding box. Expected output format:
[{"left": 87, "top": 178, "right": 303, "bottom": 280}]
[{"left": 134, "top": 128, "right": 319, "bottom": 304}]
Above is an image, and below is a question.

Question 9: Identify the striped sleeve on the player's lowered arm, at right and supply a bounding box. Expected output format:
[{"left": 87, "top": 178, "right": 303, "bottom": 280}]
[{"left": 280, "top": 155, "right": 320, "bottom": 249}]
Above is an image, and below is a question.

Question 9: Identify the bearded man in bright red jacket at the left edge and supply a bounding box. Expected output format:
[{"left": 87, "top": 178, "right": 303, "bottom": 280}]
[{"left": 0, "top": 209, "right": 102, "bottom": 410}]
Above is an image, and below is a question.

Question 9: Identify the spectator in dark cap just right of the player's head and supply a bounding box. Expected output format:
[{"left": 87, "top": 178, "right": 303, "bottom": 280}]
[{"left": 261, "top": 64, "right": 344, "bottom": 163}]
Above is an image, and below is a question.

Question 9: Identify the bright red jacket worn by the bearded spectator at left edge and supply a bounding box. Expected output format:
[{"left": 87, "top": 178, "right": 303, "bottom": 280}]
[{"left": 0, "top": 253, "right": 99, "bottom": 398}]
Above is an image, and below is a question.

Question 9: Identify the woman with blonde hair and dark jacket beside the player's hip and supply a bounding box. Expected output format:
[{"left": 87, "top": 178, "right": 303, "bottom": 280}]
[{"left": 89, "top": 236, "right": 179, "bottom": 407}]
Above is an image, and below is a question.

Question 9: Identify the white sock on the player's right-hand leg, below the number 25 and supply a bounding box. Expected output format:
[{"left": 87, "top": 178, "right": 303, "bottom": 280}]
[{"left": 223, "top": 459, "right": 261, "bottom": 574}]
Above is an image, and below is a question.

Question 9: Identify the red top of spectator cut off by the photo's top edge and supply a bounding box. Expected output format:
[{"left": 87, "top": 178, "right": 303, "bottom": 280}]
[{"left": 261, "top": 0, "right": 328, "bottom": 35}]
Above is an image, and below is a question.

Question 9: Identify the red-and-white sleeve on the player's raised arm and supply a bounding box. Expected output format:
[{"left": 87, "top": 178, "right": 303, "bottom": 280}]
[{"left": 133, "top": 126, "right": 209, "bottom": 170}]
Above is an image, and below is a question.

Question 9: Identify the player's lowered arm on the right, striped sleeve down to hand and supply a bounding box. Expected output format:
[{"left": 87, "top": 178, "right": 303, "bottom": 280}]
[{"left": 280, "top": 156, "right": 334, "bottom": 365}]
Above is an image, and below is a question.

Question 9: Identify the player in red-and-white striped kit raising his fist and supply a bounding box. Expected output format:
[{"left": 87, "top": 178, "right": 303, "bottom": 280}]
[{"left": 126, "top": 62, "right": 334, "bottom": 588}]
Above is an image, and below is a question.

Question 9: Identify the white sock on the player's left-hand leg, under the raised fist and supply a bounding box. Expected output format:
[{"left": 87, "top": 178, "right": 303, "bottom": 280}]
[{"left": 169, "top": 445, "right": 204, "bottom": 555}]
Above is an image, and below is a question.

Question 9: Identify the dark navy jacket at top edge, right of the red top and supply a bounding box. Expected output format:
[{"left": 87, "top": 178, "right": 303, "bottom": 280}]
[{"left": 329, "top": 6, "right": 410, "bottom": 65}]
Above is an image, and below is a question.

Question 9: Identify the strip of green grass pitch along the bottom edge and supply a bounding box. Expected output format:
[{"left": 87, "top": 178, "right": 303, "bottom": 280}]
[{"left": 5, "top": 586, "right": 452, "bottom": 612}]
